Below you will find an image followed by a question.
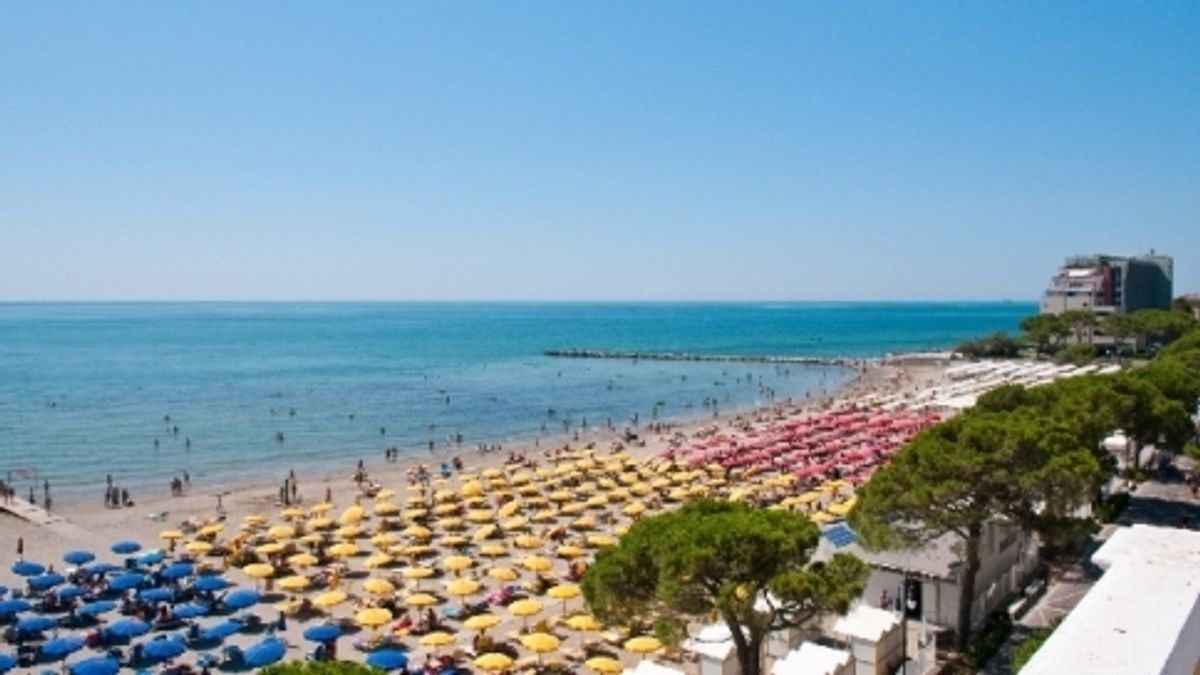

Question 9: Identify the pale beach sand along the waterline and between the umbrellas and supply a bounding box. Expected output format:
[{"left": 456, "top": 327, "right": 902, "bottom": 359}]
[{"left": 0, "top": 362, "right": 944, "bottom": 664}]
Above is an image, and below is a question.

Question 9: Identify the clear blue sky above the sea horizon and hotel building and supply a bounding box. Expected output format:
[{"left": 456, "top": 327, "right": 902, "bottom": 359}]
[{"left": 0, "top": 0, "right": 1200, "bottom": 300}]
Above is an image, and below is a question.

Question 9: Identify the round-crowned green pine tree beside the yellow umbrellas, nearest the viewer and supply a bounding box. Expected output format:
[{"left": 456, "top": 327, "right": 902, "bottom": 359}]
[{"left": 582, "top": 500, "right": 868, "bottom": 675}]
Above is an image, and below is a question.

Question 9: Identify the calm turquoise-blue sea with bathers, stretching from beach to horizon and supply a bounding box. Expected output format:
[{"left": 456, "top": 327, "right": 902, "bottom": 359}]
[{"left": 0, "top": 303, "right": 1037, "bottom": 501}]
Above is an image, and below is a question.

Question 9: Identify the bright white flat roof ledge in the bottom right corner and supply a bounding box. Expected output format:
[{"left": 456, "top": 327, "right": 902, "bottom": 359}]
[{"left": 1021, "top": 525, "right": 1200, "bottom": 675}]
